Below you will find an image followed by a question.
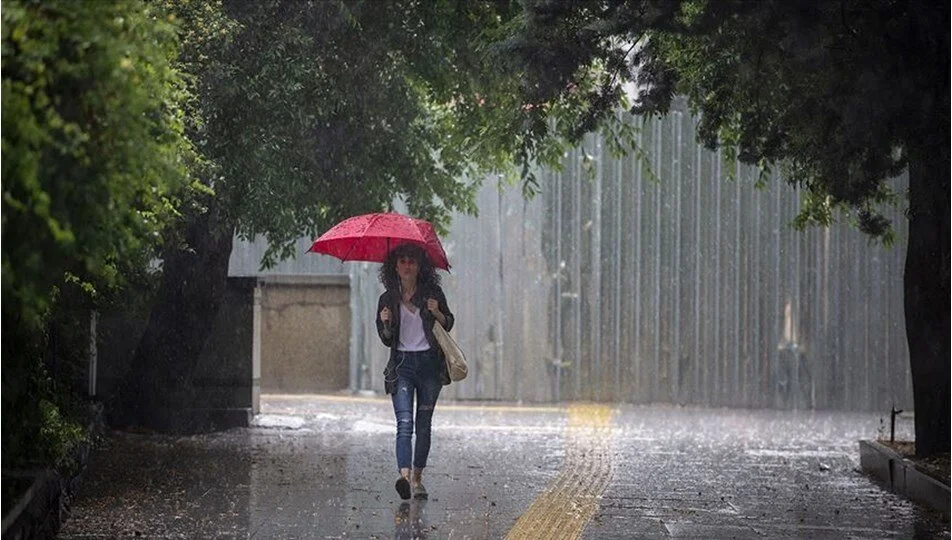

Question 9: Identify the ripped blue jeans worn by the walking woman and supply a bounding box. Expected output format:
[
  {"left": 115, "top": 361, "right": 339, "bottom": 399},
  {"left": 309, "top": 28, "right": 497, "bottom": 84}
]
[{"left": 391, "top": 350, "right": 443, "bottom": 469}]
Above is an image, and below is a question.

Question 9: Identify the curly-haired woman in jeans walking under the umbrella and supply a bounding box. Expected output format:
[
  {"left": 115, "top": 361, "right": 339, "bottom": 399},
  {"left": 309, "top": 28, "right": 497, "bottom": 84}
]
[{"left": 377, "top": 244, "right": 453, "bottom": 499}]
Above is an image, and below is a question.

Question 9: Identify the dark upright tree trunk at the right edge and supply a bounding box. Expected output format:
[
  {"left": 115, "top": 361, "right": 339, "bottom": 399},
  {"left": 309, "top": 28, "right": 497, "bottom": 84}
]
[{"left": 903, "top": 150, "right": 950, "bottom": 456}]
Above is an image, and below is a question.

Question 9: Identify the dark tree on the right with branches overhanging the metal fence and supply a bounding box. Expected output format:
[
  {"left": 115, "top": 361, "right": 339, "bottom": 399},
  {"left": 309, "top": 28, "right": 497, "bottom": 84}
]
[{"left": 501, "top": 0, "right": 950, "bottom": 455}]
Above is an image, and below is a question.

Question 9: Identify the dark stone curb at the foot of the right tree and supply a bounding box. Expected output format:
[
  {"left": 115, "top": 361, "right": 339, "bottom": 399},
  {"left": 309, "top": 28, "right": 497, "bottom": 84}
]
[{"left": 859, "top": 441, "right": 950, "bottom": 517}]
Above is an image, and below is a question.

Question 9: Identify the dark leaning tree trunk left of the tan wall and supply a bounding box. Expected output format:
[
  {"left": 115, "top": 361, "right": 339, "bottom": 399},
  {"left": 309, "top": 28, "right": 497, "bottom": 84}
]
[{"left": 117, "top": 204, "right": 233, "bottom": 431}]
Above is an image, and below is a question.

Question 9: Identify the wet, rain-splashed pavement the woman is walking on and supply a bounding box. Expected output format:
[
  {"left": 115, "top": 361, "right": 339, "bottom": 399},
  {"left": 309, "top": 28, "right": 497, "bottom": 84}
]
[{"left": 59, "top": 396, "right": 949, "bottom": 539}]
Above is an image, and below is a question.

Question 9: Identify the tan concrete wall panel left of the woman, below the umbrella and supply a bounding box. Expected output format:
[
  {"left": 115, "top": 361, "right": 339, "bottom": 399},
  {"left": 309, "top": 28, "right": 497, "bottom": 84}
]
[{"left": 259, "top": 275, "right": 351, "bottom": 393}]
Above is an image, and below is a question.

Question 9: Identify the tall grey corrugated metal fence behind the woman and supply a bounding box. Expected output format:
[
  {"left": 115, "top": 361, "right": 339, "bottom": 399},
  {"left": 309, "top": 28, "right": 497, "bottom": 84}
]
[{"left": 233, "top": 112, "right": 911, "bottom": 411}]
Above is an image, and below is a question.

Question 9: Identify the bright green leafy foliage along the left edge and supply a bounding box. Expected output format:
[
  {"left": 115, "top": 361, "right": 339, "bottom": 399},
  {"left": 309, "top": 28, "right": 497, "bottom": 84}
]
[{"left": 2, "top": 0, "right": 191, "bottom": 466}]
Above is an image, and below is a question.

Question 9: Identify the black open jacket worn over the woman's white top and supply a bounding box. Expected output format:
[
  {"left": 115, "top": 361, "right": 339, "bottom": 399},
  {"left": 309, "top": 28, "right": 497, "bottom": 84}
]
[{"left": 376, "top": 285, "right": 456, "bottom": 394}]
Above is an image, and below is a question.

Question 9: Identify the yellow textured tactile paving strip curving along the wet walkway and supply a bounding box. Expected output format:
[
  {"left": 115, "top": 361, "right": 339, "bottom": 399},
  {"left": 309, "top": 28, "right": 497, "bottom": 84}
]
[{"left": 506, "top": 405, "right": 613, "bottom": 540}]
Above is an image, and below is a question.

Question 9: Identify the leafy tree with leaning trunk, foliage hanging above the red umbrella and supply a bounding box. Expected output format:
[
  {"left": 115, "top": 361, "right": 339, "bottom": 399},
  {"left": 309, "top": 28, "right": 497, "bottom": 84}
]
[{"left": 117, "top": 0, "right": 556, "bottom": 425}]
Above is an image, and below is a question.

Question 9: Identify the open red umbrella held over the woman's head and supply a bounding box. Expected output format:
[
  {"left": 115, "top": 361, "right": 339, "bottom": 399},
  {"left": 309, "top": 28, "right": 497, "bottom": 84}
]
[{"left": 308, "top": 212, "right": 450, "bottom": 271}]
